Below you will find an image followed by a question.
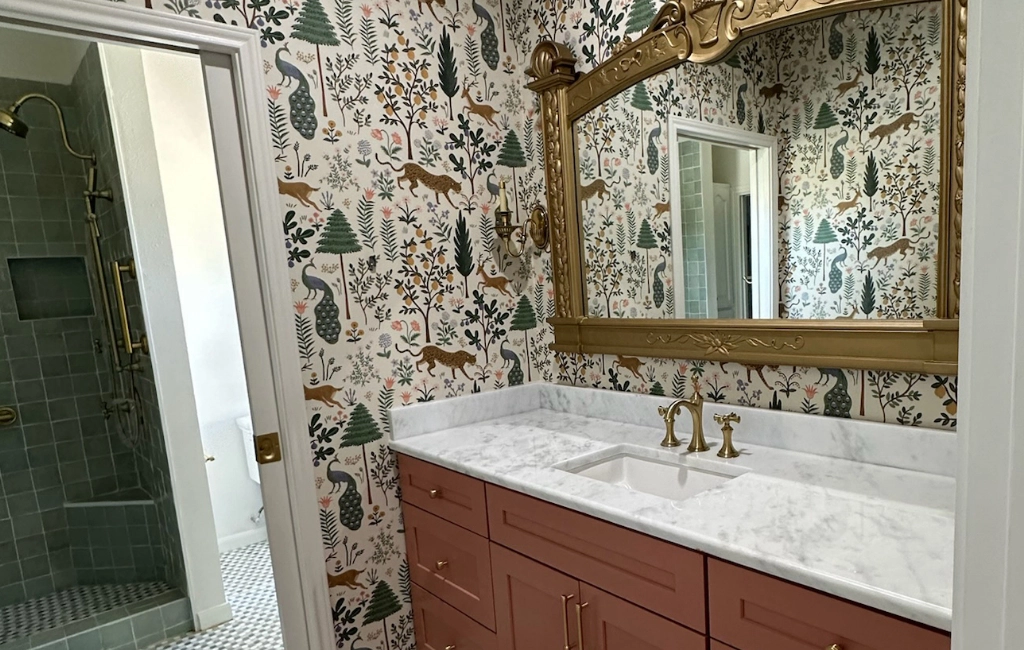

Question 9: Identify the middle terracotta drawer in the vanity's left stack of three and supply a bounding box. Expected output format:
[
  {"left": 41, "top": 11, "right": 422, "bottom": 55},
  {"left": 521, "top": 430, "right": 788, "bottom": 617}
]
[{"left": 402, "top": 504, "right": 495, "bottom": 630}]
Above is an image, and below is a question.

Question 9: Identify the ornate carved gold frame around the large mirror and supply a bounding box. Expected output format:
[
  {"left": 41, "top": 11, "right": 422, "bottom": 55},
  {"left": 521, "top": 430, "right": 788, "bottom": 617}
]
[{"left": 527, "top": 0, "right": 967, "bottom": 375}]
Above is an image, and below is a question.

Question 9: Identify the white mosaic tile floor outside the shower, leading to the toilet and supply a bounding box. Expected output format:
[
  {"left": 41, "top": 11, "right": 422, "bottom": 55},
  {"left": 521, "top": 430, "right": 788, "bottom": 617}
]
[{"left": 151, "top": 541, "right": 284, "bottom": 650}]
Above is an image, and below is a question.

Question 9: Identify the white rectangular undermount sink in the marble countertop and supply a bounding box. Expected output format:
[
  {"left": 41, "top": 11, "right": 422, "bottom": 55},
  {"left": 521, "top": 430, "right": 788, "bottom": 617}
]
[{"left": 571, "top": 453, "right": 735, "bottom": 501}]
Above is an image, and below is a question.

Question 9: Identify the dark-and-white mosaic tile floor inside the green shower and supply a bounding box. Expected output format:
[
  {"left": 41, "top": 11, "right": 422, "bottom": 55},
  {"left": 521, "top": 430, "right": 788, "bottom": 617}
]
[{"left": 0, "top": 582, "right": 171, "bottom": 644}]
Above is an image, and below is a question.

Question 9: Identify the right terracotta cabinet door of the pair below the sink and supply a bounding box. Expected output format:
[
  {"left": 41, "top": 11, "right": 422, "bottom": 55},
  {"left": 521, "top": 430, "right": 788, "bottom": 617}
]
[{"left": 573, "top": 583, "right": 706, "bottom": 650}]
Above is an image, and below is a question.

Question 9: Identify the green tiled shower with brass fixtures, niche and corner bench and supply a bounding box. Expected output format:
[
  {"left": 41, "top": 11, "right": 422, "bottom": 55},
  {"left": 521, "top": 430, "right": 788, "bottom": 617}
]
[{"left": 0, "top": 44, "right": 191, "bottom": 650}]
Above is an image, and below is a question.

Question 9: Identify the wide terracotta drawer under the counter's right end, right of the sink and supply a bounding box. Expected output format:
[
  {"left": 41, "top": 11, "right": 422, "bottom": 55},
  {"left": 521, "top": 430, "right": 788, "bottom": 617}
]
[{"left": 708, "top": 559, "right": 950, "bottom": 650}]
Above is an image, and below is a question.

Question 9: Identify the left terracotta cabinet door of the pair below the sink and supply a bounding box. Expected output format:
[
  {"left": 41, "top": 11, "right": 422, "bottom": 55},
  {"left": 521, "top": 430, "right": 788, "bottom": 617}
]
[{"left": 490, "top": 544, "right": 580, "bottom": 650}]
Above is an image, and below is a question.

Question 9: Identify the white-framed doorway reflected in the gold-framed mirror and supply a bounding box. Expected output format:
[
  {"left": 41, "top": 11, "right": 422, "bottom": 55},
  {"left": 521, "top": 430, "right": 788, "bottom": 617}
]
[{"left": 669, "top": 117, "right": 779, "bottom": 318}]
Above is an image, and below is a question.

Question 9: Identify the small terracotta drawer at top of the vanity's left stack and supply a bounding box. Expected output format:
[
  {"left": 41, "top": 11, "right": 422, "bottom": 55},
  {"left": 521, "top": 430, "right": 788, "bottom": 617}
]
[{"left": 398, "top": 454, "right": 487, "bottom": 537}]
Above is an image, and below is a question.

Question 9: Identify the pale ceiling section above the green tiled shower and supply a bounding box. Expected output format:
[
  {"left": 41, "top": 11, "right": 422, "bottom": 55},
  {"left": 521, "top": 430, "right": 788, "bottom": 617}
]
[{"left": 0, "top": 27, "right": 89, "bottom": 84}]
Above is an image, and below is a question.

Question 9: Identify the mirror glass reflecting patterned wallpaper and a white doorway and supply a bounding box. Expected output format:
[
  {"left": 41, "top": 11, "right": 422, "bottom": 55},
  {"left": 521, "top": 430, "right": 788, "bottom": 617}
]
[{"left": 574, "top": 1, "right": 942, "bottom": 319}]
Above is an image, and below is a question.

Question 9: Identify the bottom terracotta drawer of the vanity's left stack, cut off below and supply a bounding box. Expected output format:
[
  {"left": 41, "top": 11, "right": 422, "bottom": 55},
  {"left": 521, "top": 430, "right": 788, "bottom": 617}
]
[{"left": 413, "top": 584, "right": 498, "bottom": 650}]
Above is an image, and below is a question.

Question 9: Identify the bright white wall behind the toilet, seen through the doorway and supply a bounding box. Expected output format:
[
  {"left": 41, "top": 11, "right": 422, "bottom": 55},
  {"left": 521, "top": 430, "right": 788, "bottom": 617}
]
[{"left": 142, "top": 51, "right": 266, "bottom": 552}]
